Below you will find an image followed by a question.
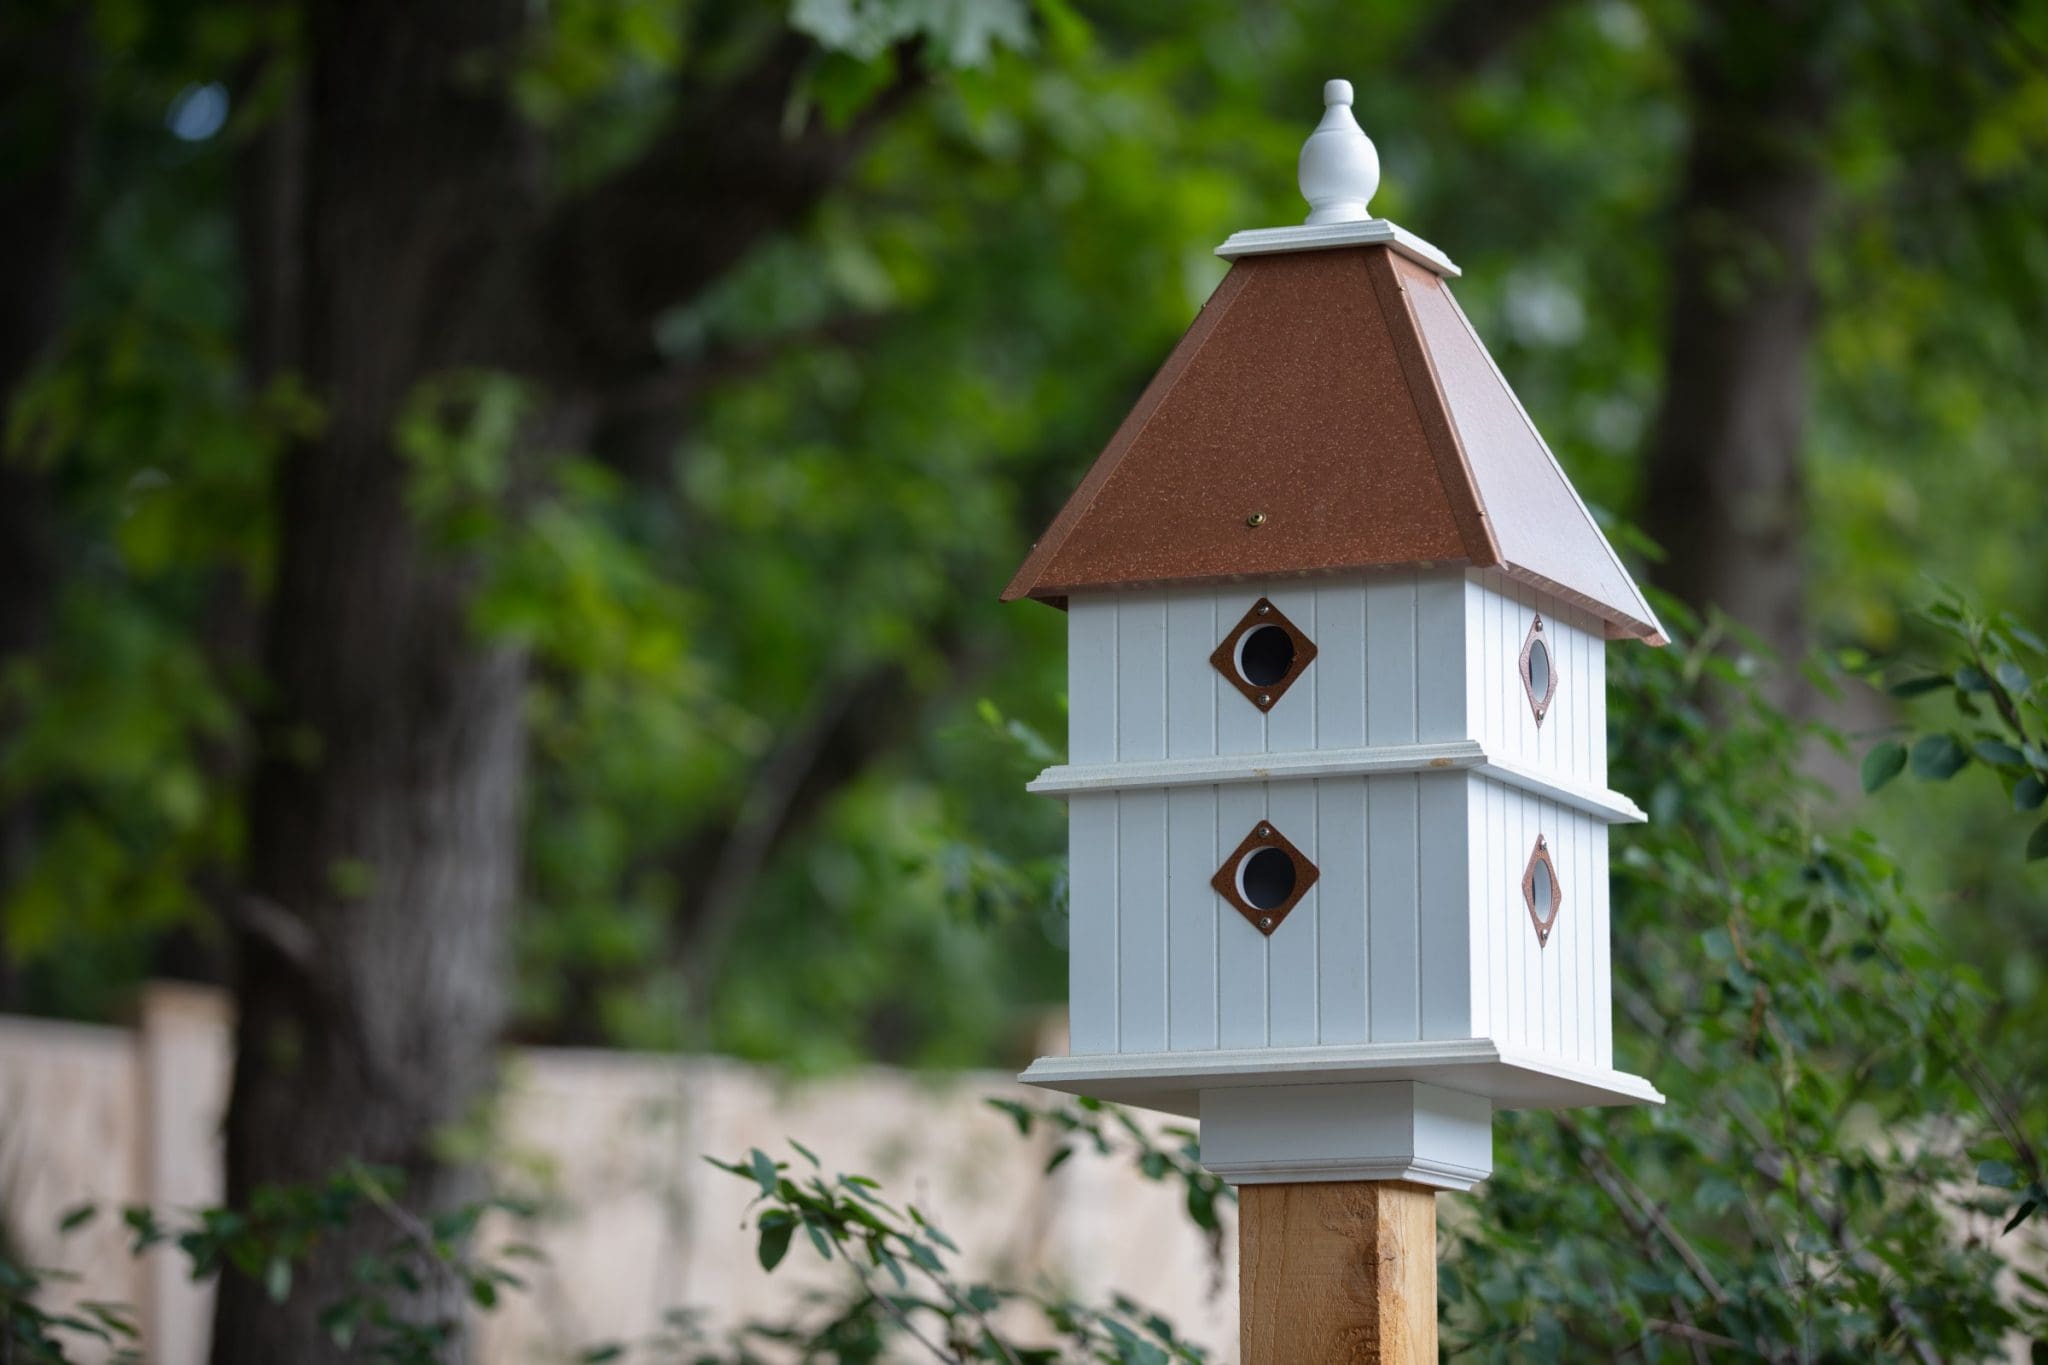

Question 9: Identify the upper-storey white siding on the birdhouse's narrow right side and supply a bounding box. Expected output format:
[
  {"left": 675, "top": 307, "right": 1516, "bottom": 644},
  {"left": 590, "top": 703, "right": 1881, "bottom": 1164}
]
[{"left": 1464, "top": 569, "right": 1608, "bottom": 786}]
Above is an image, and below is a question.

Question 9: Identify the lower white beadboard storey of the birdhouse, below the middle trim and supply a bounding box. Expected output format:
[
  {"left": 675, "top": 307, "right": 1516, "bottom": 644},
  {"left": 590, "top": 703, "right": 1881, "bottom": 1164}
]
[{"left": 1065, "top": 769, "right": 1626, "bottom": 1074}]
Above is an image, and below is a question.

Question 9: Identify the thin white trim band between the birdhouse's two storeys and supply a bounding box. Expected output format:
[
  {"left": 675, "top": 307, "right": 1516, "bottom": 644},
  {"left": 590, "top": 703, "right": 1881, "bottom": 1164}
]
[{"left": 1026, "top": 739, "right": 1649, "bottom": 825}]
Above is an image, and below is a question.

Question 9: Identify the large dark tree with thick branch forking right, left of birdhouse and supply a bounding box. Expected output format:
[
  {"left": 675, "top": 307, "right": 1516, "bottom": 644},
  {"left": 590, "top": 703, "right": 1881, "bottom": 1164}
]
[{"left": 215, "top": 2, "right": 983, "bottom": 1361}]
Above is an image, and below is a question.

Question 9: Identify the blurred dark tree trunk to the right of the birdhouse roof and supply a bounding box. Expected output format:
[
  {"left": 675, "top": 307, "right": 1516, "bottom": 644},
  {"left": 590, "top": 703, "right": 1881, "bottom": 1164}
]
[{"left": 1642, "top": 0, "right": 1835, "bottom": 687}]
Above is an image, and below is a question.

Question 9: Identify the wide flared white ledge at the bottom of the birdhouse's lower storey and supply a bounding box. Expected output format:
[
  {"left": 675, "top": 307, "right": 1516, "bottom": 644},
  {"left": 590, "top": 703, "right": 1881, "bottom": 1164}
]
[{"left": 1018, "top": 1038, "right": 1663, "bottom": 1119}]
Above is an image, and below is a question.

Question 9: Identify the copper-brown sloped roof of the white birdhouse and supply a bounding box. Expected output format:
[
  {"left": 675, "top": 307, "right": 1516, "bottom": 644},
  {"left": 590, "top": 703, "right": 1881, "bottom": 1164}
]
[{"left": 1004, "top": 246, "right": 1663, "bottom": 645}]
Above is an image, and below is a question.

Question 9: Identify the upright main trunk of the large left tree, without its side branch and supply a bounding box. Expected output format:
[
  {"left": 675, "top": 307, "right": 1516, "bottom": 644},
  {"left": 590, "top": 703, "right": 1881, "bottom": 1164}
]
[{"left": 213, "top": 0, "right": 535, "bottom": 1365}]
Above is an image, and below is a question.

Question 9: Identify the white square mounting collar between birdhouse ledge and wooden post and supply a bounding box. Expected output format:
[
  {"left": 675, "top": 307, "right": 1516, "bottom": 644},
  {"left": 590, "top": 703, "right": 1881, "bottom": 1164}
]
[{"left": 1200, "top": 1081, "right": 1493, "bottom": 1189}]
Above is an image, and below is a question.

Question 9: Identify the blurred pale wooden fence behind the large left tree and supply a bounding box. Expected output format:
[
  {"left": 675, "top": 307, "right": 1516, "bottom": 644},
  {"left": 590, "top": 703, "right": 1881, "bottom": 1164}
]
[{"left": 0, "top": 984, "right": 1237, "bottom": 1365}]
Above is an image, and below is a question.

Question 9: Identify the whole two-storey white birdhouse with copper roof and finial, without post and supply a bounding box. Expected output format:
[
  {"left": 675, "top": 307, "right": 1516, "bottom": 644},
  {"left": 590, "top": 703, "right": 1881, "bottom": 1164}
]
[{"left": 1004, "top": 80, "right": 1663, "bottom": 1189}]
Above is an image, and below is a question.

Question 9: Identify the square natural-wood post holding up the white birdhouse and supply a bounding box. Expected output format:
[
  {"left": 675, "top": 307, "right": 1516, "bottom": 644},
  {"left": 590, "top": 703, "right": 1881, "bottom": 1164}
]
[{"left": 1237, "top": 1181, "right": 1436, "bottom": 1365}]
